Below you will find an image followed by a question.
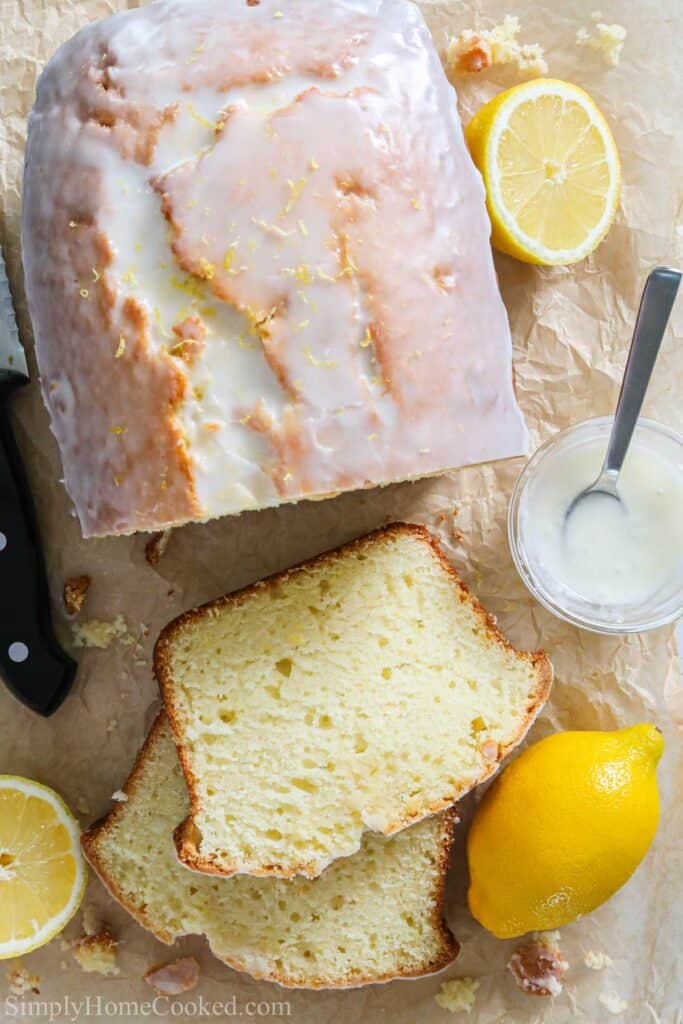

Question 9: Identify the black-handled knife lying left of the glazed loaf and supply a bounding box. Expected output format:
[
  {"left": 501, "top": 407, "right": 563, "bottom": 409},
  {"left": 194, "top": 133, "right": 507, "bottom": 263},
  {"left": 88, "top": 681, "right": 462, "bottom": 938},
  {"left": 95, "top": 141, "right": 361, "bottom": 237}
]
[{"left": 0, "top": 244, "right": 76, "bottom": 716}]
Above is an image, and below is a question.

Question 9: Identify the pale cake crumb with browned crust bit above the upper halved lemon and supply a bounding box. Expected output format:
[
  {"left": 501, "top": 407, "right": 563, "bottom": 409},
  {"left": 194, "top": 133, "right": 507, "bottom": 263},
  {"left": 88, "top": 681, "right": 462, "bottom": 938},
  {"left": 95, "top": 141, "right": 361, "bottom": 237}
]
[{"left": 445, "top": 14, "right": 548, "bottom": 76}]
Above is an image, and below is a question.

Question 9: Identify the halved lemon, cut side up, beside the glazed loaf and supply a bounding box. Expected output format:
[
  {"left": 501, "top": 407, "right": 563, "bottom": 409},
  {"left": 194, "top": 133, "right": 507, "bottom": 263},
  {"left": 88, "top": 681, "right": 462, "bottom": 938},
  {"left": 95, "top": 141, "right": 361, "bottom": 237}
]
[{"left": 465, "top": 78, "right": 622, "bottom": 264}]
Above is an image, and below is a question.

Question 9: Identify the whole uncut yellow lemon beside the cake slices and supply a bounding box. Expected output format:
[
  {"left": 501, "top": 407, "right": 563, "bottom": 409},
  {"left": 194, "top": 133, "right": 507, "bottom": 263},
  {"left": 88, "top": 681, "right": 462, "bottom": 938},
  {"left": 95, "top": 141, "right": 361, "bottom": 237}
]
[{"left": 467, "top": 724, "right": 664, "bottom": 939}]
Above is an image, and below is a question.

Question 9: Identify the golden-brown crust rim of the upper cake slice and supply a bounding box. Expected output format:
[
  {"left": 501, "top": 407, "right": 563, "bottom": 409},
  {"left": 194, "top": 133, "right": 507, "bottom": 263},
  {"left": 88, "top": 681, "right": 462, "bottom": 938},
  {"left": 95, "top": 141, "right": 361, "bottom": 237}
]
[{"left": 154, "top": 522, "right": 553, "bottom": 878}]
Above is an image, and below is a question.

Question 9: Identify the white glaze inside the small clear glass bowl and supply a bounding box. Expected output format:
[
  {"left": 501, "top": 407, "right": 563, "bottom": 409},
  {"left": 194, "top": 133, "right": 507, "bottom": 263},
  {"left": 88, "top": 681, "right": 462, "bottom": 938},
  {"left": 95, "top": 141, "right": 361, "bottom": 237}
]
[{"left": 520, "top": 435, "right": 683, "bottom": 606}]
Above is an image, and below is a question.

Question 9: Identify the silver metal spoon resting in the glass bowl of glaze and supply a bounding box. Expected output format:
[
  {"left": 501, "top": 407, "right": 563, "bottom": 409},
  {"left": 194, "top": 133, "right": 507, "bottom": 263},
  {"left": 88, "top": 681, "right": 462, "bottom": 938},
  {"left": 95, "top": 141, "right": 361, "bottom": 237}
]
[{"left": 564, "top": 266, "right": 681, "bottom": 527}]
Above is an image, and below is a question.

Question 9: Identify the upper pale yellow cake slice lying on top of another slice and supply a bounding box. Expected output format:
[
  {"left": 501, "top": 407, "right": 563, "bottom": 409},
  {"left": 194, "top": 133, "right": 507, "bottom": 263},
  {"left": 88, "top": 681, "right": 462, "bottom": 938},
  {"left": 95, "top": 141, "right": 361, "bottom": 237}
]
[{"left": 155, "top": 523, "right": 552, "bottom": 878}]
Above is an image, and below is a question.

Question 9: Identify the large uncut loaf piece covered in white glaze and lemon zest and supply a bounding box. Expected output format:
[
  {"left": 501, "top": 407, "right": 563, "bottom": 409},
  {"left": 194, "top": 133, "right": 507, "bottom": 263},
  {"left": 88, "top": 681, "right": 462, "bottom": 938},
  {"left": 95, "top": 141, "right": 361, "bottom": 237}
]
[{"left": 18, "top": 0, "right": 526, "bottom": 537}]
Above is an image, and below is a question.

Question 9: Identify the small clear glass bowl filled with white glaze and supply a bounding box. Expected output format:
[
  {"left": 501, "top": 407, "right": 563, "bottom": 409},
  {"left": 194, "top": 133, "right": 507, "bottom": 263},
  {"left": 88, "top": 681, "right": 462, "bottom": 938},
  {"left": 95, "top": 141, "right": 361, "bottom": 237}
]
[{"left": 508, "top": 418, "right": 683, "bottom": 633}]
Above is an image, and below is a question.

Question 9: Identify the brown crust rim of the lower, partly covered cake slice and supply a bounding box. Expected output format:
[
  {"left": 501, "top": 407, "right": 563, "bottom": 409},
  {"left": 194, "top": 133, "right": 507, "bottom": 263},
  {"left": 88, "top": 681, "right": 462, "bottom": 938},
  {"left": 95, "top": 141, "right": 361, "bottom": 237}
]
[{"left": 81, "top": 711, "right": 460, "bottom": 989}]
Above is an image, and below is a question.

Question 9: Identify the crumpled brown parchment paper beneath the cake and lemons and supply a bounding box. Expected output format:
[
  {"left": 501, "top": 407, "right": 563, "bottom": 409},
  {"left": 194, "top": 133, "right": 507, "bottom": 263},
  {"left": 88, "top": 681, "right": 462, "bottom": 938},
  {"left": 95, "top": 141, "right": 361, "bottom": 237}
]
[{"left": 0, "top": 0, "right": 683, "bottom": 1024}]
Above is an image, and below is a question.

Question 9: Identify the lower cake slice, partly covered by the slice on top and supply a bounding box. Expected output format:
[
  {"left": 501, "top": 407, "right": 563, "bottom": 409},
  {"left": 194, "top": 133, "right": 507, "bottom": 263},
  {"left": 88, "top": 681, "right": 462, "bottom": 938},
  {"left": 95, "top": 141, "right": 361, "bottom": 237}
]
[{"left": 83, "top": 716, "right": 458, "bottom": 988}]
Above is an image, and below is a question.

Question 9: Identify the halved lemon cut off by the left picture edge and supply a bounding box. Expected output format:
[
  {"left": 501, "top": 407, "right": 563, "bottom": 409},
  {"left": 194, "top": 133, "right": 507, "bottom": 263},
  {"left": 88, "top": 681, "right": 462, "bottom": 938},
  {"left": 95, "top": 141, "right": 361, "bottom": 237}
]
[{"left": 0, "top": 775, "right": 87, "bottom": 959}]
